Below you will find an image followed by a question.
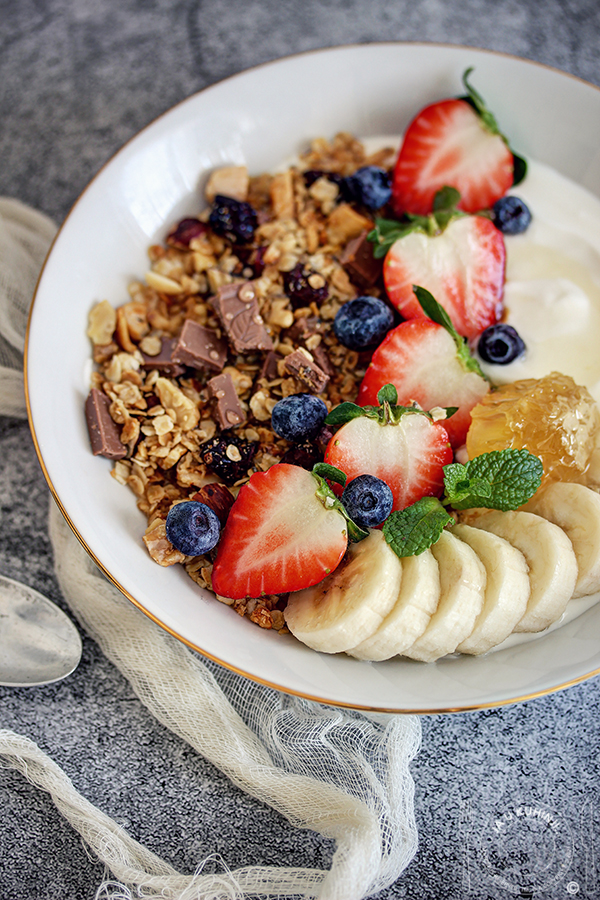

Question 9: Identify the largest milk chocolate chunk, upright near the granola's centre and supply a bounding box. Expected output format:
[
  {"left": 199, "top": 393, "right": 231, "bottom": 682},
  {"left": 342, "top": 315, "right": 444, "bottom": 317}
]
[{"left": 212, "top": 281, "right": 273, "bottom": 353}]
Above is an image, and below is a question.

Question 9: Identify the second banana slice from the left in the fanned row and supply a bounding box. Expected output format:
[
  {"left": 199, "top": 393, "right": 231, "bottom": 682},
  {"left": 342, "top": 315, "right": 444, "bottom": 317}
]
[{"left": 348, "top": 550, "right": 440, "bottom": 660}]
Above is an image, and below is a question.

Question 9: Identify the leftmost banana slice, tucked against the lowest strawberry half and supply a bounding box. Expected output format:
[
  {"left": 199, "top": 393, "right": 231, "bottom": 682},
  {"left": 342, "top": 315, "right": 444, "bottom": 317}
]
[{"left": 285, "top": 531, "right": 402, "bottom": 653}]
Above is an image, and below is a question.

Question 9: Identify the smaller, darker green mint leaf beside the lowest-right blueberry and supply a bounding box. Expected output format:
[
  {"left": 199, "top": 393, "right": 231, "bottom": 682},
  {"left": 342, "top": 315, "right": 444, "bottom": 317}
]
[{"left": 383, "top": 497, "right": 454, "bottom": 557}]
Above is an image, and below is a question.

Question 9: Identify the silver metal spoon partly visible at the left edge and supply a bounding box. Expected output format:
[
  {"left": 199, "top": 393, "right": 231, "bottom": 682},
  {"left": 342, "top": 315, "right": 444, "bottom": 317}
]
[{"left": 0, "top": 575, "right": 81, "bottom": 687}]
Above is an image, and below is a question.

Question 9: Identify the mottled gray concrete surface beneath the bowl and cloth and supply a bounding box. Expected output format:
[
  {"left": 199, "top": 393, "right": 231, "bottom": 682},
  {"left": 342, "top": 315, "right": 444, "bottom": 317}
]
[{"left": 0, "top": 0, "right": 600, "bottom": 900}]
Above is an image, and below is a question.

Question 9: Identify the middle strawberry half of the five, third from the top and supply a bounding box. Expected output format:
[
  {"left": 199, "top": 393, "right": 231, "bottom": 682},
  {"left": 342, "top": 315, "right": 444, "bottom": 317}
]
[{"left": 357, "top": 318, "right": 489, "bottom": 448}]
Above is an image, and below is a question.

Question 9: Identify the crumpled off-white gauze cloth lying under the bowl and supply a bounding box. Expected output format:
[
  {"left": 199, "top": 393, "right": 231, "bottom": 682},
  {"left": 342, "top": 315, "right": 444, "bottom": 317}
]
[{"left": 0, "top": 199, "right": 420, "bottom": 900}]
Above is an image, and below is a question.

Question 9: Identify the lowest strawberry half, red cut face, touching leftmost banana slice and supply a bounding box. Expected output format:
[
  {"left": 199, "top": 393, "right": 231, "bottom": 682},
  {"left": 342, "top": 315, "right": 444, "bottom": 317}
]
[{"left": 212, "top": 463, "right": 348, "bottom": 600}]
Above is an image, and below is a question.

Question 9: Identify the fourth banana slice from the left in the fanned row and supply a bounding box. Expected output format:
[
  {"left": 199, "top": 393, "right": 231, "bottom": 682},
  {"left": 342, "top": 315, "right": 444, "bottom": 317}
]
[{"left": 450, "top": 524, "right": 531, "bottom": 655}]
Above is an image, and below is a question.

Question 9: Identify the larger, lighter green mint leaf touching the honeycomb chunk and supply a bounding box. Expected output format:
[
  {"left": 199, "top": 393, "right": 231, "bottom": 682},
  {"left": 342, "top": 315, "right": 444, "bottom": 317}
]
[{"left": 444, "top": 449, "right": 544, "bottom": 510}]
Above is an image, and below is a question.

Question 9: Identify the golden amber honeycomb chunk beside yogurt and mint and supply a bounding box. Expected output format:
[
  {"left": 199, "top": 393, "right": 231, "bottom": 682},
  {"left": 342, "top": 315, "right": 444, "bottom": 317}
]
[{"left": 467, "top": 372, "right": 600, "bottom": 484}]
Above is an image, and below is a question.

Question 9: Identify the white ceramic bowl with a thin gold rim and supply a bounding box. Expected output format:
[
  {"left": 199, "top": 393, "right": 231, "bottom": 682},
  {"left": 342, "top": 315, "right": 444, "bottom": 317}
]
[{"left": 26, "top": 44, "right": 600, "bottom": 712}]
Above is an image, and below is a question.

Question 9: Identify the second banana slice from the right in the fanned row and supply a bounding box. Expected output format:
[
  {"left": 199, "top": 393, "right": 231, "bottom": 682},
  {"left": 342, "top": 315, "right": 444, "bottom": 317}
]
[{"left": 469, "top": 510, "right": 577, "bottom": 632}]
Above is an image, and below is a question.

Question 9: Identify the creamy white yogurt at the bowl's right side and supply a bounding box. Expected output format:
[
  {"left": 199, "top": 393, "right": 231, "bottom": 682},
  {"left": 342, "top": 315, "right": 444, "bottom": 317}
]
[{"left": 482, "top": 161, "right": 600, "bottom": 401}]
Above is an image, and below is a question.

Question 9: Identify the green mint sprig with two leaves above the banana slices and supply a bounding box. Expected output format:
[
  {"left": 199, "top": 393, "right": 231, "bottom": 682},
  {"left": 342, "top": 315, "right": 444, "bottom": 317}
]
[{"left": 383, "top": 449, "right": 543, "bottom": 557}]
